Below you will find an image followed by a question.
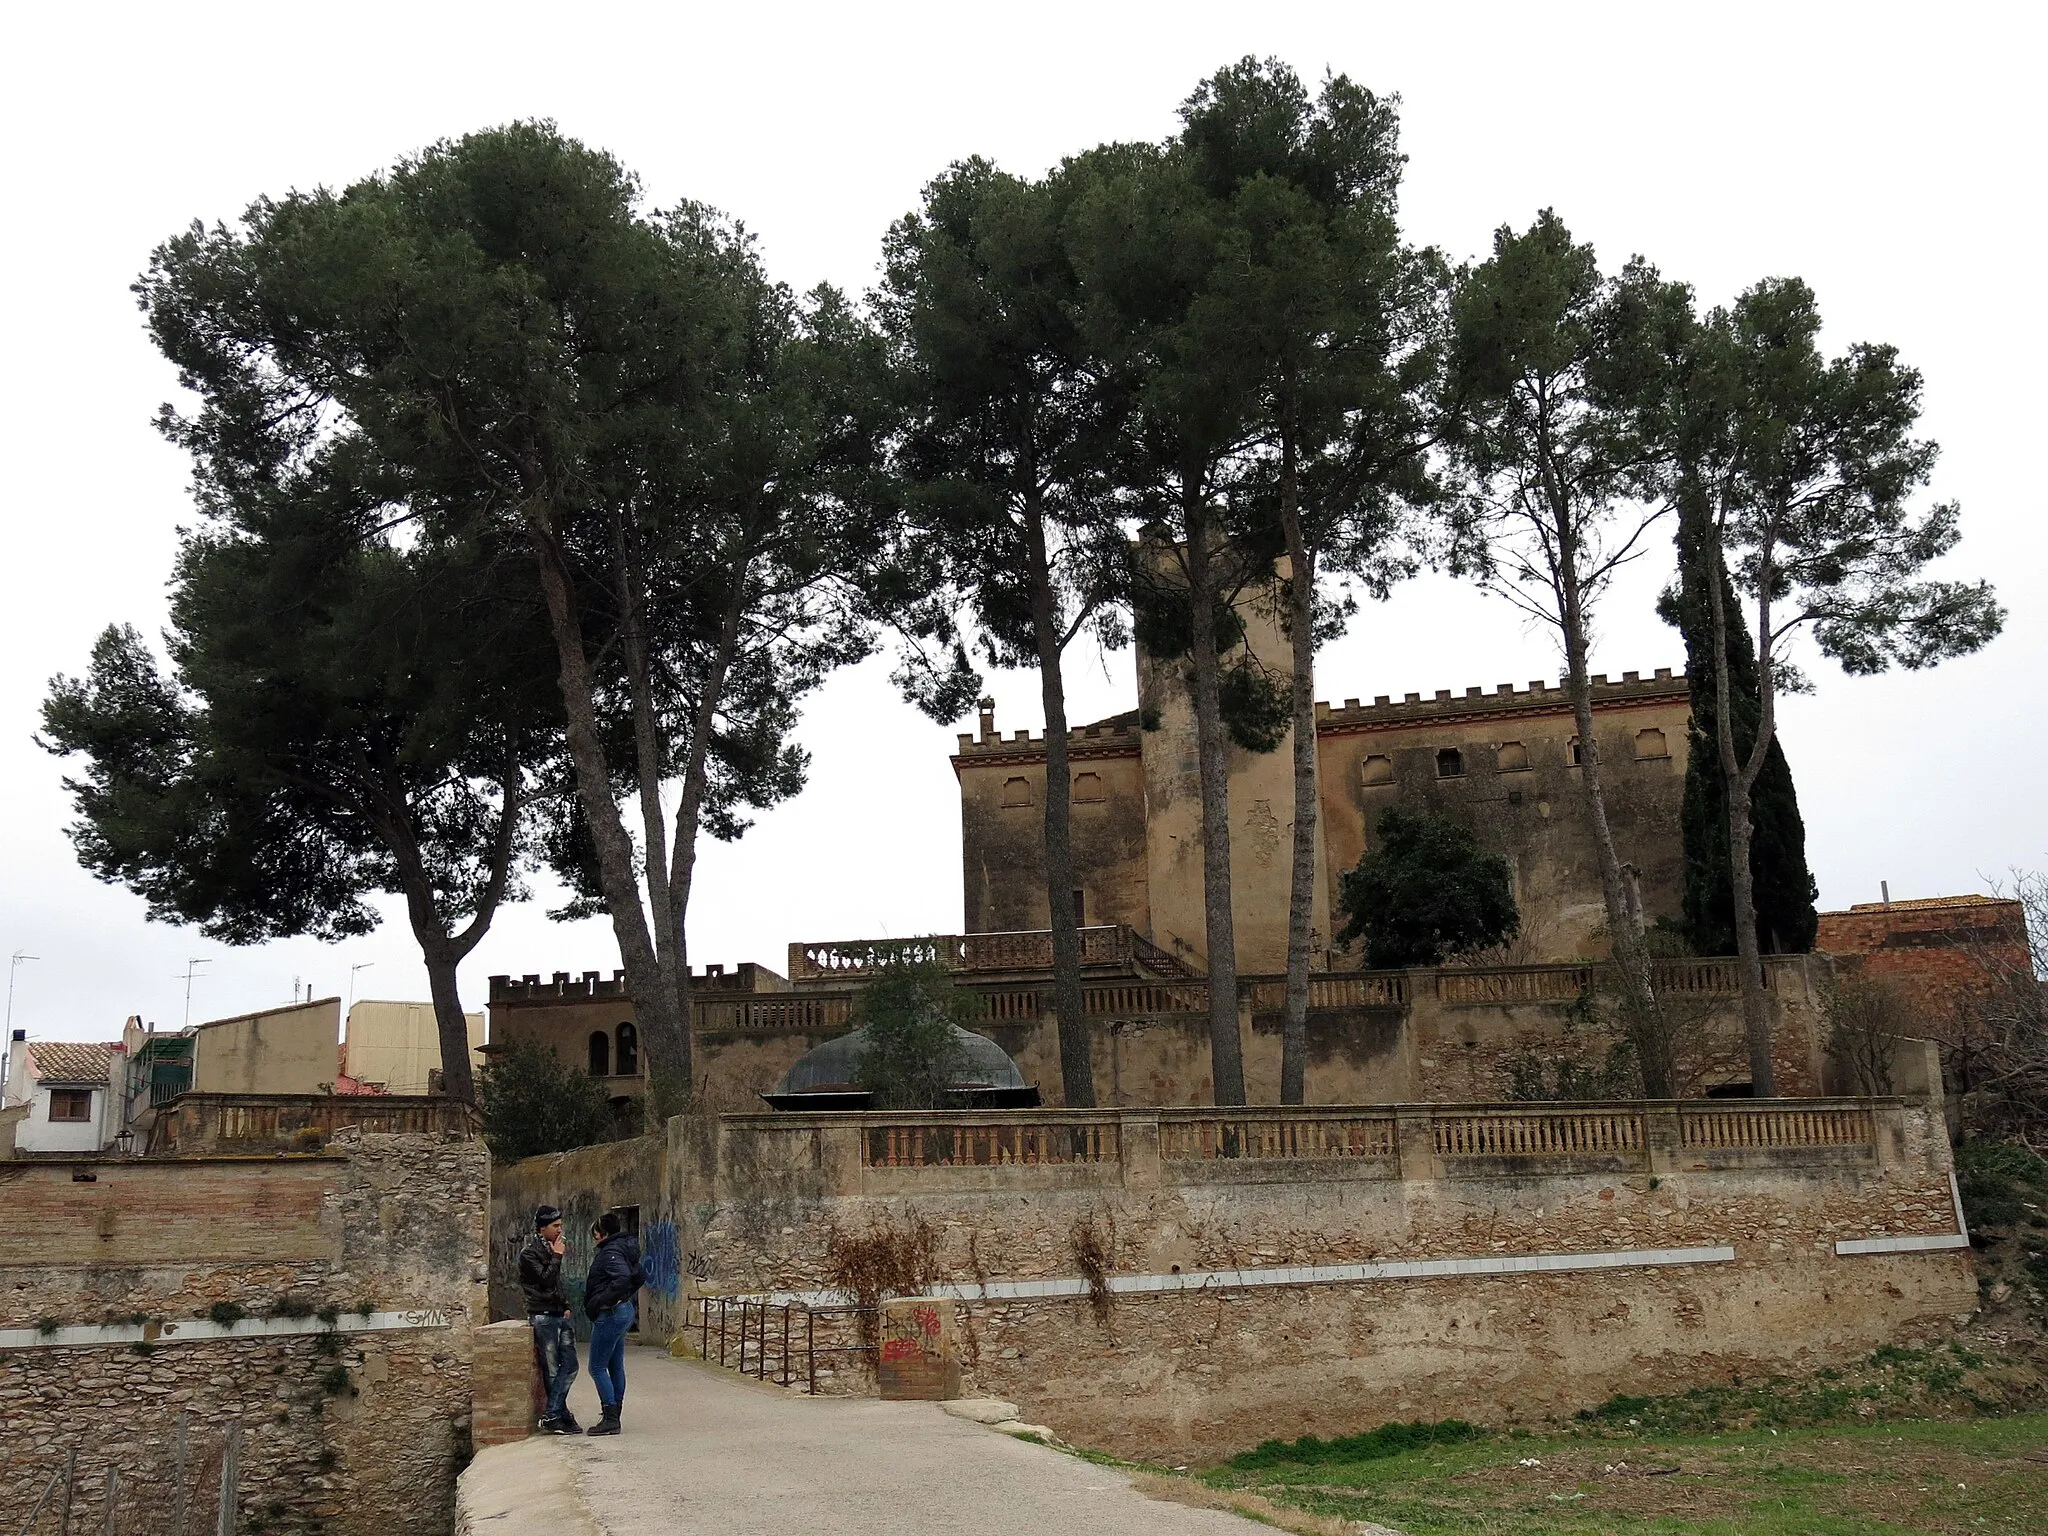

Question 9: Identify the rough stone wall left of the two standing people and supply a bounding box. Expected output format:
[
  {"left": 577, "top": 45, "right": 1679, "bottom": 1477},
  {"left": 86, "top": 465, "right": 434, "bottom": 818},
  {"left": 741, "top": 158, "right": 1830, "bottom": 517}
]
[{"left": 0, "top": 1128, "right": 487, "bottom": 1536}]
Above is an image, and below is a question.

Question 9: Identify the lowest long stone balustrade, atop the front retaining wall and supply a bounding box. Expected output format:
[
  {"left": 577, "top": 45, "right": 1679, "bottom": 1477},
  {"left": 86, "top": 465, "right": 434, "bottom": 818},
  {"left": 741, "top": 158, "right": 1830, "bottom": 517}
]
[{"left": 721, "top": 1098, "right": 1929, "bottom": 1194}]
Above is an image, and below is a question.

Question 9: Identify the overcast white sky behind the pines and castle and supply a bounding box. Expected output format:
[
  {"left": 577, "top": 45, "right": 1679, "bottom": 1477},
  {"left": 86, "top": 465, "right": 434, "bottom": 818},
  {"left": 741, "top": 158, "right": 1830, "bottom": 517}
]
[{"left": 0, "top": 0, "right": 2048, "bottom": 1038}]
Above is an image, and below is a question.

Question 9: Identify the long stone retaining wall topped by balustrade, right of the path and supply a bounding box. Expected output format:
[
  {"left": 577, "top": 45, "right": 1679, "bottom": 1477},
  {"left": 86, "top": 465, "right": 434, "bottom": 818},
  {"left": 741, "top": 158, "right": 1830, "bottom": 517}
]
[{"left": 668, "top": 1100, "right": 1976, "bottom": 1458}]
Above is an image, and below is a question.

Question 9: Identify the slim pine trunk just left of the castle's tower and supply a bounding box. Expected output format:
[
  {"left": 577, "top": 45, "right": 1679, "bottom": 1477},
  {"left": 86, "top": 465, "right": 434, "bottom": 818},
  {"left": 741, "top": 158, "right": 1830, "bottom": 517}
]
[{"left": 1024, "top": 504, "right": 1096, "bottom": 1110}]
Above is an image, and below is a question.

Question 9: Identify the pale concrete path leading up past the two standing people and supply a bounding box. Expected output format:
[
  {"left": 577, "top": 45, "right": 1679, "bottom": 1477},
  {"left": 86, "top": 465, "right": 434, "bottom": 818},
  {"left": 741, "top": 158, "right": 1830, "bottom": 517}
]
[{"left": 528, "top": 1350, "right": 1266, "bottom": 1536}]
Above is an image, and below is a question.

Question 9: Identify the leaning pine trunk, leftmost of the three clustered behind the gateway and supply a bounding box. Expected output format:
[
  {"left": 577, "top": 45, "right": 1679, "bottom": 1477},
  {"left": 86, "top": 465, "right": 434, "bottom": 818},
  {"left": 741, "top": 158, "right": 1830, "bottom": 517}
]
[{"left": 526, "top": 508, "right": 690, "bottom": 1071}]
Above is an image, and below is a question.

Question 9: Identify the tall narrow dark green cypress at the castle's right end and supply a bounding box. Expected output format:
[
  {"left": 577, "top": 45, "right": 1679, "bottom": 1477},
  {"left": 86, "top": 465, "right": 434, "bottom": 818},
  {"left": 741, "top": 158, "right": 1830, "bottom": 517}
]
[{"left": 1661, "top": 496, "right": 1821, "bottom": 954}]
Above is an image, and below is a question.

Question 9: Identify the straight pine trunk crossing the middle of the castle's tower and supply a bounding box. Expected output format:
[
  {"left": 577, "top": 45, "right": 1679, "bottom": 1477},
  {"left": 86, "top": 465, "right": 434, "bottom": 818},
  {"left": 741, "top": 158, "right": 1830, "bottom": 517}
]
[{"left": 1182, "top": 473, "right": 1245, "bottom": 1104}]
